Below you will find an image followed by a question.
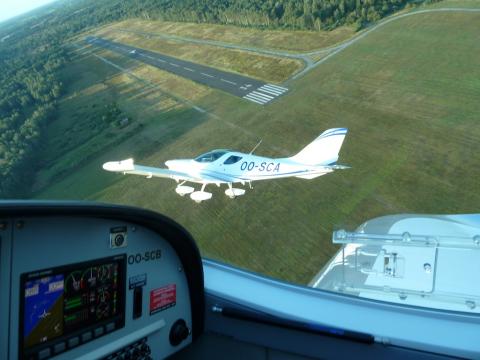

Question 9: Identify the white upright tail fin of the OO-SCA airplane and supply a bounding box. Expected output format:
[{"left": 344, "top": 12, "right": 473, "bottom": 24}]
[{"left": 290, "top": 128, "right": 348, "bottom": 165}]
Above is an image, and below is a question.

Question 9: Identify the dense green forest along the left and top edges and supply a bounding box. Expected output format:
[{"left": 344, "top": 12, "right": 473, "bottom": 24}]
[{"left": 0, "top": 0, "right": 436, "bottom": 198}]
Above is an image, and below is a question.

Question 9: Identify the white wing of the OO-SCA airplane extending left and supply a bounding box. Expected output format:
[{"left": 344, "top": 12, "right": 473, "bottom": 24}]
[{"left": 103, "top": 159, "right": 202, "bottom": 181}]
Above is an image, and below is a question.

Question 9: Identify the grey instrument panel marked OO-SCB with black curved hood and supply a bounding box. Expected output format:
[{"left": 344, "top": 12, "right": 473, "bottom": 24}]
[{"left": 0, "top": 202, "right": 204, "bottom": 360}]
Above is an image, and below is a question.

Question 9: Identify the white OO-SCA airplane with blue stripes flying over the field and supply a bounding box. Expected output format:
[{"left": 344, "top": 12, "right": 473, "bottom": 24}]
[{"left": 103, "top": 128, "right": 349, "bottom": 202}]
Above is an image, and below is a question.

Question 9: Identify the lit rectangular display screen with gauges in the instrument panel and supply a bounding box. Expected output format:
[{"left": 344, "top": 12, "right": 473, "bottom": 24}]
[{"left": 20, "top": 255, "right": 126, "bottom": 358}]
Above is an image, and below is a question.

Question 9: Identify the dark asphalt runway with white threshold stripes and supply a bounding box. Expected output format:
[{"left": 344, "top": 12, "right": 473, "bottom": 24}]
[{"left": 85, "top": 36, "right": 288, "bottom": 105}]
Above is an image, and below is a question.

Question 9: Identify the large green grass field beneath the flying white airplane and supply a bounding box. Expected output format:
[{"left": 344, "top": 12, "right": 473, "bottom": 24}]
[{"left": 37, "top": 2, "right": 480, "bottom": 283}]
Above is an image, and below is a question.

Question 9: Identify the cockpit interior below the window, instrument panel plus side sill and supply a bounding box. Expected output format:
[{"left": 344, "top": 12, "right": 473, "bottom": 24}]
[{"left": 0, "top": 201, "right": 470, "bottom": 360}]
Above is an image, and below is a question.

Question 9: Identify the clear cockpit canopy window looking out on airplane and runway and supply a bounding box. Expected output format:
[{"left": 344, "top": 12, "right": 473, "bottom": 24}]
[{"left": 0, "top": 0, "right": 480, "bottom": 312}]
